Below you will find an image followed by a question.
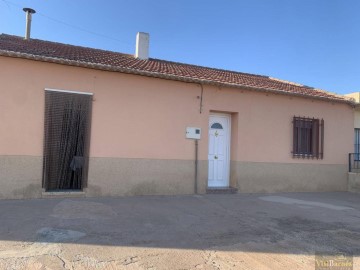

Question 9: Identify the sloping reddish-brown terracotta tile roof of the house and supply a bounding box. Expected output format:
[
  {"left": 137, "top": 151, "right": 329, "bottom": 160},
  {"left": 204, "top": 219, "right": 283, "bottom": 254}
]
[{"left": 0, "top": 34, "right": 351, "bottom": 103}]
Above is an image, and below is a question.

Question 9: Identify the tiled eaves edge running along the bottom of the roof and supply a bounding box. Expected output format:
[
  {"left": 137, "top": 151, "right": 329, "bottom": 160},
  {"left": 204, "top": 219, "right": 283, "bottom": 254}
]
[{"left": 0, "top": 50, "right": 356, "bottom": 107}]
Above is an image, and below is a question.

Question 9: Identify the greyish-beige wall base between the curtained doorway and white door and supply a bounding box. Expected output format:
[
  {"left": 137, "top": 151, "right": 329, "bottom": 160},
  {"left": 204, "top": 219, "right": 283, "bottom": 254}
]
[{"left": 86, "top": 158, "right": 207, "bottom": 196}]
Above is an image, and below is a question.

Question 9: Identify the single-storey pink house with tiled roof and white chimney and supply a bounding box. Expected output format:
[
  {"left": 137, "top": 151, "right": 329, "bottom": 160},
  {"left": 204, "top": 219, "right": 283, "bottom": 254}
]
[{"left": 0, "top": 33, "right": 354, "bottom": 198}]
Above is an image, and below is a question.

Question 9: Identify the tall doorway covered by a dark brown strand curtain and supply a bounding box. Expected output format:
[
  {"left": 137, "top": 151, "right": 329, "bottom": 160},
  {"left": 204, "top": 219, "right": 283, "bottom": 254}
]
[{"left": 42, "top": 91, "right": 92, "bottom": 191}]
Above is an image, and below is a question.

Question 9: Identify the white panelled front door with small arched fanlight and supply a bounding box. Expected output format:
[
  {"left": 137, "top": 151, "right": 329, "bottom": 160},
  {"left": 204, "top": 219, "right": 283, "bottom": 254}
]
[{"left": 208, "top": 114, "right": 230, "bottom": 187}]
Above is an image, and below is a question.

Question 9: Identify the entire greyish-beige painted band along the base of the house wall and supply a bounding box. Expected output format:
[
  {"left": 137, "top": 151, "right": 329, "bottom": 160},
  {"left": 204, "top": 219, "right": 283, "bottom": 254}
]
[{"left": 0, "top": 156, "right": 348, "bottom": 199}]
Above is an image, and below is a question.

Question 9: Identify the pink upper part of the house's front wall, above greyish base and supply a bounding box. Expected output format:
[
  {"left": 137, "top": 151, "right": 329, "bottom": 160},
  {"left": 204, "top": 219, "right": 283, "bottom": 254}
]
[{"left": 0, "top": 57, "right": 353, "bottom": 164}]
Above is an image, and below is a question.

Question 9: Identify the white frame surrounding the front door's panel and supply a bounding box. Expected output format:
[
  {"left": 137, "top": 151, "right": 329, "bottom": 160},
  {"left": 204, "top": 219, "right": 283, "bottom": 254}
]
[{"left": 206, "top": 112, "right": 231, "bottom": 188}]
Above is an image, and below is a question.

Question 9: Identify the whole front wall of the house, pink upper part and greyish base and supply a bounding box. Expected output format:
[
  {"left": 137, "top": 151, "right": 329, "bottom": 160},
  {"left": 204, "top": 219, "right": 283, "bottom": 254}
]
[{"left": 0, "top": 57, "right": 354, "bottom": 198}]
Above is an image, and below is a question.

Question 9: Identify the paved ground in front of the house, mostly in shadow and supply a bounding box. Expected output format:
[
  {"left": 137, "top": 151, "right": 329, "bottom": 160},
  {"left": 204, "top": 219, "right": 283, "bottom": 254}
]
[{"left": 0, "top": 192, "right": 360, "bottom": 270}]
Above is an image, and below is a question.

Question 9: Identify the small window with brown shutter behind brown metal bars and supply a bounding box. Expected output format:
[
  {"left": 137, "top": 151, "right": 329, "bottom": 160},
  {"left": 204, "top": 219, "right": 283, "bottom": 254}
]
[{"left": 292, "top": 116, "right": 324, "bottom": 159}]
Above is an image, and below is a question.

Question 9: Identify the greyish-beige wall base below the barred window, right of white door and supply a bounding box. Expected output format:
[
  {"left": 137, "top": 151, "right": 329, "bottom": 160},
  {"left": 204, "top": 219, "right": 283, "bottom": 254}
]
[{"left": 233, "top": 161, "right": 348, "bottom": 193}]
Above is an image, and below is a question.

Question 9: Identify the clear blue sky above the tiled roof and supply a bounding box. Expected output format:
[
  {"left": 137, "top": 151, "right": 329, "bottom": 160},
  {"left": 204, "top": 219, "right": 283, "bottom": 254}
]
[{"left": 0, "top": 0, "right": 360, "bottom": 94}]
